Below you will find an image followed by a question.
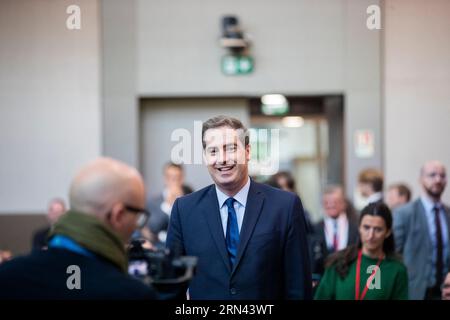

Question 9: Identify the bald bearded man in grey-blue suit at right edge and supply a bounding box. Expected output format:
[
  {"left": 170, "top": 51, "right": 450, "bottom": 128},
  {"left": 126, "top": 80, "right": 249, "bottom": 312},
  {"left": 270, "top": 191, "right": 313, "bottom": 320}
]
[{"left": 393, "top": 161, "right": 450, "bottom": 300}]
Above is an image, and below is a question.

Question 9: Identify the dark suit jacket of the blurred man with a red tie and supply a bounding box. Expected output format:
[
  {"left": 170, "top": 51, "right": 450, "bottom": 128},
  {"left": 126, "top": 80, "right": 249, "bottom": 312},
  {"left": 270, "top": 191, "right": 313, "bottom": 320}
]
[{"left": 309, "top": 219, "right": 359, "bottom": 278}]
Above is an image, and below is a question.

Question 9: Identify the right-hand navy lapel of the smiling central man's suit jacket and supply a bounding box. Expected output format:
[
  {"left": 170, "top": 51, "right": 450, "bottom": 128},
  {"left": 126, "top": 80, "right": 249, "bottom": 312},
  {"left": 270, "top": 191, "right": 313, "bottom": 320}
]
[{"left": 232, "top": 181, "right": 264, "bottom": 273}]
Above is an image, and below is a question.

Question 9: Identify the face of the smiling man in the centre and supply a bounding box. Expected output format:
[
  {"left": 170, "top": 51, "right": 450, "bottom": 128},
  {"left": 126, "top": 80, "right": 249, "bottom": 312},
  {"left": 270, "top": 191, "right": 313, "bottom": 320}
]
[{"left": 204, "top": 127, "right": 250, "bottom": 196}]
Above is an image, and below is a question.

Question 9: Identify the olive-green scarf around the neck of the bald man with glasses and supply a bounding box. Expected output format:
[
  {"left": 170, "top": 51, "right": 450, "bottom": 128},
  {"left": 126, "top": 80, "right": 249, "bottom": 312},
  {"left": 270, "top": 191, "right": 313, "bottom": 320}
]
[{"left": 49, "top": 211, "right": 128, "bottom": 273}]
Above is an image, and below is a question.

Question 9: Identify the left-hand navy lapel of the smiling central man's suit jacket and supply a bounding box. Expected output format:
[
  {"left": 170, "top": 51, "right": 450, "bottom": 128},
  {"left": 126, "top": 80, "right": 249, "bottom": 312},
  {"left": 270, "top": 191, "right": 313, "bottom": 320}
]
[{"left": 203, "top": 185, "right": 231, "bottom": 273}]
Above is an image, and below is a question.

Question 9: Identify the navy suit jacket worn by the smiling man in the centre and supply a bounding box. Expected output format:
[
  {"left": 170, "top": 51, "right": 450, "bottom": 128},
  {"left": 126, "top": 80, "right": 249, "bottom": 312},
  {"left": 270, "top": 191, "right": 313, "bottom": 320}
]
[{"left": 167, "top": 181, "right": 312, "bottom": 299}]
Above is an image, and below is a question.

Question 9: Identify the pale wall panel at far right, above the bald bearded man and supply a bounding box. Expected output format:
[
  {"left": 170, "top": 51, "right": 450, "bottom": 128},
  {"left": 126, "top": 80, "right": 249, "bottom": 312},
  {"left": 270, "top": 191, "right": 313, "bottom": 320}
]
[{"left": 384, "top": 0, "right": 450, "bottom": 203}]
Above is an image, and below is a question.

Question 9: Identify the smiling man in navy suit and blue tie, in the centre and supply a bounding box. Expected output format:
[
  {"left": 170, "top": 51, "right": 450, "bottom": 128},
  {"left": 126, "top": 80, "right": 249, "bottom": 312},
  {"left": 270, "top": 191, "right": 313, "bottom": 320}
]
[{"left": 167, "top": 116, "right": 312, "bottom": 299}]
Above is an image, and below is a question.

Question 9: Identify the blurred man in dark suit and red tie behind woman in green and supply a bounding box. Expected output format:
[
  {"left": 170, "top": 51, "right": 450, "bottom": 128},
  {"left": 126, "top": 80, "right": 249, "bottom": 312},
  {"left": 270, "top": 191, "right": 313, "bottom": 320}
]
[{"left": 310, "top": 186, "right": 359, "bottom": 280}]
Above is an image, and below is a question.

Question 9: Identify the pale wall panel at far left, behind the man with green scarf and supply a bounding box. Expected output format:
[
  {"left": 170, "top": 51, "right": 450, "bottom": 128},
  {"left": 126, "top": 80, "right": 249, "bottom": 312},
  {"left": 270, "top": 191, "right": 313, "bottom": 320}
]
[{"left": 0, "top": 0, "right": 101, "bottom": 213}]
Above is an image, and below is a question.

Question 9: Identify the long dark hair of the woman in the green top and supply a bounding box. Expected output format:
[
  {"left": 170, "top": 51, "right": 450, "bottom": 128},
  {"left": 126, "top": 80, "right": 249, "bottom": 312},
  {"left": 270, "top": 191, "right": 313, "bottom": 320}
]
[{"left": 325, "top": 202, "right": 398, "bottom": 278}]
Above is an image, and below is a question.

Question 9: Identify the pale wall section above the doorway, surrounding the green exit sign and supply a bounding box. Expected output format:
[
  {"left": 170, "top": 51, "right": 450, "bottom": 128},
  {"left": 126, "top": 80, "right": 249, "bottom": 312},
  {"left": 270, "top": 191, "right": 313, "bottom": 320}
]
[{"left": 137, "top": 0, "right": 346, "bottom": 95}]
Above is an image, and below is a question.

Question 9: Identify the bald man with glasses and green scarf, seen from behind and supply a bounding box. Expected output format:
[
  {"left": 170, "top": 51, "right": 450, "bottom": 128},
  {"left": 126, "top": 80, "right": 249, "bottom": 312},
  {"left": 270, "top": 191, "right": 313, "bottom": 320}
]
[{"left": 0, "top": 158, "right": 156, "bottom": 300}]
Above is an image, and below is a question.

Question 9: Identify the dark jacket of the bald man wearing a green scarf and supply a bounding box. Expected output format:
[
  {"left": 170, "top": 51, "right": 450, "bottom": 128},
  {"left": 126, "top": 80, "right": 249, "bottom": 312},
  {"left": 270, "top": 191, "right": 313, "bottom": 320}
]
[{"left": 0, "top": 248, "right": 156, "bottom": 300}]
